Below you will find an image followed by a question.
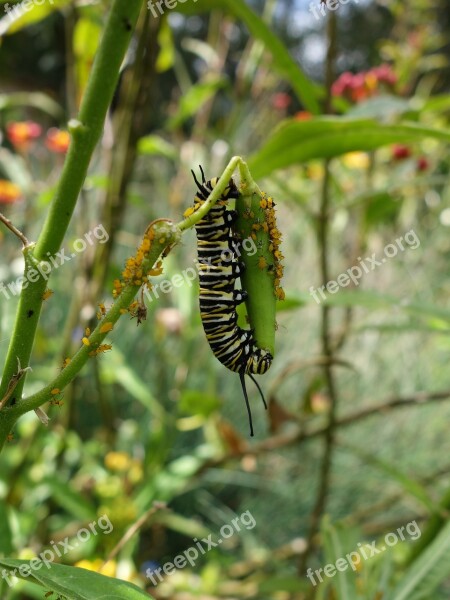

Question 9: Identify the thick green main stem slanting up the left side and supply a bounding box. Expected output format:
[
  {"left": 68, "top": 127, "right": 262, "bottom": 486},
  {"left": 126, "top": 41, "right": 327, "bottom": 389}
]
[{"left": 0, "top": 0, "right": 142, "bottom": 401}]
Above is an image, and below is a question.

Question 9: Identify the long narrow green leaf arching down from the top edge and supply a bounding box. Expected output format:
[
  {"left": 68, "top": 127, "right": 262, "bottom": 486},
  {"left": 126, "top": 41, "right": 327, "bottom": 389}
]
[{"left": 177, "top": 0, "right": 322, "bottom": 114}]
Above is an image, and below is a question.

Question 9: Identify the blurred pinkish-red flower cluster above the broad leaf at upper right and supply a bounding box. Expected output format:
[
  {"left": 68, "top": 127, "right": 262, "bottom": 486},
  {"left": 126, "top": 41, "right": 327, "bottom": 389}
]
[{"left": 331, "top": 64, "right": 397, "bottom": 102}]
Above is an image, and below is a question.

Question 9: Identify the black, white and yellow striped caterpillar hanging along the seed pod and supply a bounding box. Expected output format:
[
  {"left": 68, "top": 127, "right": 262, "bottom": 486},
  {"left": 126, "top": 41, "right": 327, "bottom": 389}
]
[{"left": 192, "top": 167, "right": 272, "bottom": 436}]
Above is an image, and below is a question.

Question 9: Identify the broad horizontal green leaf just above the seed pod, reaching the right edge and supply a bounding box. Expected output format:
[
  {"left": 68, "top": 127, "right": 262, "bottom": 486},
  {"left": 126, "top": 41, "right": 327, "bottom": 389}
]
[{"left": 248, "top": 117, "right": 450, "bottom": 179}]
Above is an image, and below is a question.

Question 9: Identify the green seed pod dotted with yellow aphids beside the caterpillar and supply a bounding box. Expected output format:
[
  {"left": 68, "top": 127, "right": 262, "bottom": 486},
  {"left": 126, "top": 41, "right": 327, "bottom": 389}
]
[{"left": 234, "top": 185, "right": 284, "bottom": 356}]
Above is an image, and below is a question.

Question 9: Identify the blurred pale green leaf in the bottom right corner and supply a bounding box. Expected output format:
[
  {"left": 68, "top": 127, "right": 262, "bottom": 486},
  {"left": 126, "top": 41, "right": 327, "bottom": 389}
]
[{"left": 388, "top": 523, "right": 450, "bottom": 600}]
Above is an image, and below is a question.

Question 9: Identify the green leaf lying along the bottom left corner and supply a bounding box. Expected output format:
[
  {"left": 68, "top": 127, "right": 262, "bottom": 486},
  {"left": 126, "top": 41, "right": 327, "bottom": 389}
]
[{"left": 0, "top": 558, "right": 151, "bottom": 600}]
